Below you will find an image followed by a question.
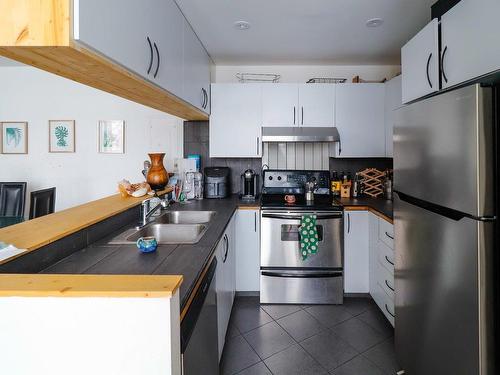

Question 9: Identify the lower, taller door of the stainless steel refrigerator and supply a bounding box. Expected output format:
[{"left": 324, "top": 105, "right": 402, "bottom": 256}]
[{"left": 394, "top": 196, "right": 494, "bottom": 375}]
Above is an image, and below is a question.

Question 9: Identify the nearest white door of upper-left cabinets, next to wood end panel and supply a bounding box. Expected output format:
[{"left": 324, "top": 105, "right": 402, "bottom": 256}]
[{"left": 74, "top": 0, "right": 152, "bottom": 79}]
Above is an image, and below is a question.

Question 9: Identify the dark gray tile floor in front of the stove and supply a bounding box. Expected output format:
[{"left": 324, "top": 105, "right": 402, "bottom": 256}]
[{"left": 220, "top": 297, "right": 399, "bottom": 375}]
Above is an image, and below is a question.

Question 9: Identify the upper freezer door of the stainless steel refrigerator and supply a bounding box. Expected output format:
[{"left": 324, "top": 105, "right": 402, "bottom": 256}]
[{"left": 394, "top": 85, "right": 494, "bottom": 216}]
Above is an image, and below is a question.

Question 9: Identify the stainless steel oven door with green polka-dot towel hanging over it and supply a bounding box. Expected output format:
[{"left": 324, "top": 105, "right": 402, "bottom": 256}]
[{"left": 260, "top": 210, "right": 344, "bottom": 270}]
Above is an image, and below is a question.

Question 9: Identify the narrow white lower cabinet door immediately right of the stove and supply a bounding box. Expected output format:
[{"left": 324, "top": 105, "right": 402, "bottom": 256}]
[{"left": 344, "top": 211, "right": 370, "bottom": 293}]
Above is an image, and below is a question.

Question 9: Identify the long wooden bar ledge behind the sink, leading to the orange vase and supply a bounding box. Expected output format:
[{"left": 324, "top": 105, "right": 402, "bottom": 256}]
[{"left": 0, "top": 188, "right": 172, "bottom": 264}]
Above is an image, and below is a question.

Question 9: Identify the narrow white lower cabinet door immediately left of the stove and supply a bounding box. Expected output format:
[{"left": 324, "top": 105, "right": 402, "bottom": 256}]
[{"left": 236, "top": 209, "right": 260, "bottom": 292}]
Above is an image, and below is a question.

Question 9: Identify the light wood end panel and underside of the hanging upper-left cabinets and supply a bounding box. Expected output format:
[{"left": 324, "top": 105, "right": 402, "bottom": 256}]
[{"left": 0, "top": 0, "right": 208, "bottom": 120}]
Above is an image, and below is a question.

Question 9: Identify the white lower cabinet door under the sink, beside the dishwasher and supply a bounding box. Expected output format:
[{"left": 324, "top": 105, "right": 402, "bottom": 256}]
[{"left": 215, "top": 215, "right": 236, "bottom": 360}]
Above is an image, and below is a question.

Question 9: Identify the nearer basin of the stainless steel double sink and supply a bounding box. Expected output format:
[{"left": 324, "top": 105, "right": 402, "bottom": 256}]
[{"left": 125, "top": 224, "right": 207, "bottom": 244}]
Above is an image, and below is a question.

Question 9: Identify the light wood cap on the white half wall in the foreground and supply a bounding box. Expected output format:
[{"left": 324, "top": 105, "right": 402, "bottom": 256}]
[{"left": 0, "top": 274, "right": 183, "bottom": 298}]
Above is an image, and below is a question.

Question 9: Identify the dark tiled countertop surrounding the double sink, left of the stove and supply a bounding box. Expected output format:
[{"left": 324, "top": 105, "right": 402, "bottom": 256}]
[{"left": 42, "top": 195, "right": 252, "bottom": 310}]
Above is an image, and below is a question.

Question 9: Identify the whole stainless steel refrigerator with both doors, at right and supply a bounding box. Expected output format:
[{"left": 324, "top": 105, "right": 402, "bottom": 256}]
[{"left": 394, "top": 85, "right": 500, "bottom": 375}]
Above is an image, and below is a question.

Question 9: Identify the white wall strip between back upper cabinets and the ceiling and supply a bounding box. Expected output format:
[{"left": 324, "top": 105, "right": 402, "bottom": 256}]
[{"left": 214, "top": 65, "right": 401, "bottom": 83}]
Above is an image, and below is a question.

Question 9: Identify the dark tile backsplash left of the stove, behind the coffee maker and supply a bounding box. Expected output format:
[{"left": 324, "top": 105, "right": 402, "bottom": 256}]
[{"left": 184, "top": 121, "right": 262, "bottom": 194}]
